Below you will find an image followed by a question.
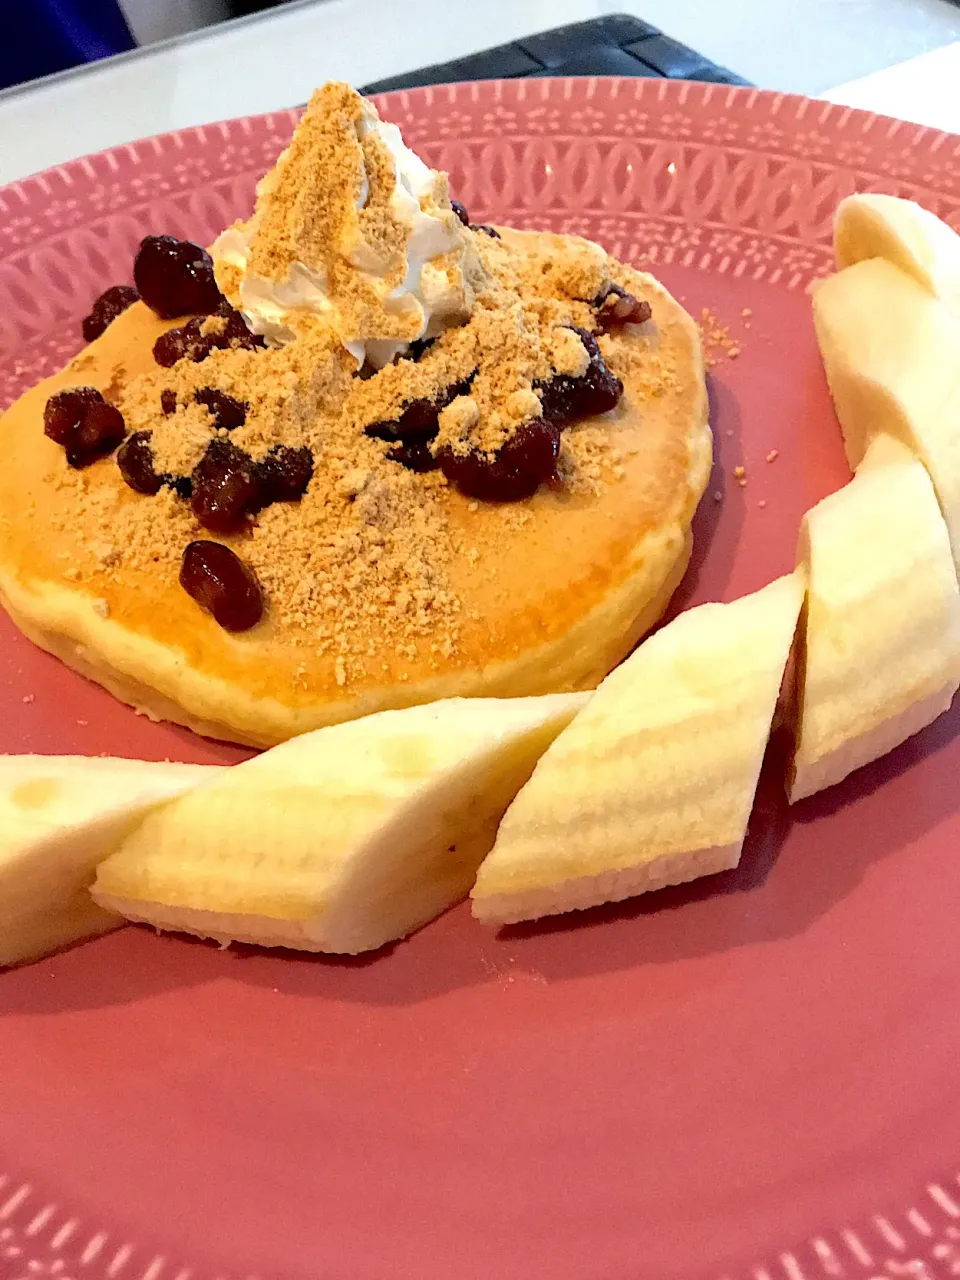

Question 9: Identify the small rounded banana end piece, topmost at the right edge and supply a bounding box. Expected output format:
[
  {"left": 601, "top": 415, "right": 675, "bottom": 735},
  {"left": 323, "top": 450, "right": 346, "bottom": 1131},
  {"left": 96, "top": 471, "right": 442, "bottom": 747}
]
[{"left": 833, "top": 192, "right": 960, "bottom": 316}]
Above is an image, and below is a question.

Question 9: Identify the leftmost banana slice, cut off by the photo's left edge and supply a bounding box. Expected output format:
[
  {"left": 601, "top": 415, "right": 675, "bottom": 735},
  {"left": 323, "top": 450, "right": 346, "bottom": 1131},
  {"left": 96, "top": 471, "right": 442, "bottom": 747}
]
[{"left": 0, "top": 755, "right": 220, "bottom": 965}]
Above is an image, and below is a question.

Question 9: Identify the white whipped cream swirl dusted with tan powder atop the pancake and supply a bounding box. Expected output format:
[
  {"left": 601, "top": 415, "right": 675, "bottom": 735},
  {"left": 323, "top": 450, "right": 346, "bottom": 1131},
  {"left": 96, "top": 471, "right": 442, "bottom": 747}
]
[{"left": 211, "top": 83, "right": 484, "bottom": 367}]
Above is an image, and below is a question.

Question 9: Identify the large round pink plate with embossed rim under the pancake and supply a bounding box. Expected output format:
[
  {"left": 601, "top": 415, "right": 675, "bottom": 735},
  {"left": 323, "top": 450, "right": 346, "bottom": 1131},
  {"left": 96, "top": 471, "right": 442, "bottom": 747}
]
[{"left": 0, "top": 79, "right": 960, "bottom": 1280}]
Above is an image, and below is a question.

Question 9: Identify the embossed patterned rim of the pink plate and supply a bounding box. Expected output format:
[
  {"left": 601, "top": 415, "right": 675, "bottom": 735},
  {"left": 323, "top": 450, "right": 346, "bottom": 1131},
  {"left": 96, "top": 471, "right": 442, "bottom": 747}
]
[{"left": 0, "top": 79, "right": 960, "bottom": 1280}]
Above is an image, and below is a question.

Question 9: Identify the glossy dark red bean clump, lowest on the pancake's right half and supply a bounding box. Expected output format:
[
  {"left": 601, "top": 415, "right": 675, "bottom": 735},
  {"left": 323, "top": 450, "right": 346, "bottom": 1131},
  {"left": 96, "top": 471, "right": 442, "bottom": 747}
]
[{"left": 438, "top": 417, "right": 561, "bottom": 502}]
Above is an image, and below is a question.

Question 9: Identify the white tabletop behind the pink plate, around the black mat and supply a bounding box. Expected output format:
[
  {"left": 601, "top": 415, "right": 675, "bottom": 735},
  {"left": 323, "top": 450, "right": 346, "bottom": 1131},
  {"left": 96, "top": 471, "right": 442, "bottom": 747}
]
[{"left": 0, "top": 0, "right": 960, "bottom": 184}]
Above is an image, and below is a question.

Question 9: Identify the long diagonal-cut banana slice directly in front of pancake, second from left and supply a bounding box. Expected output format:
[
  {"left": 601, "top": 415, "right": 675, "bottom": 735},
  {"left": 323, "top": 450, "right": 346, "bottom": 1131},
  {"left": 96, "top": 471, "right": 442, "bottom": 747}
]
[{"left": 93, "top": 694, "right": 590, "bottom": 954}]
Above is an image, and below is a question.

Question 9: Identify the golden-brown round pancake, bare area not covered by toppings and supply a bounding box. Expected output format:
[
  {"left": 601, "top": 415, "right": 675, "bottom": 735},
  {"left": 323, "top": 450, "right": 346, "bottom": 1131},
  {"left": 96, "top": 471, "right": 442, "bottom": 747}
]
[{"left": 0, "top": 238, "right": 712, "bottom": 746}]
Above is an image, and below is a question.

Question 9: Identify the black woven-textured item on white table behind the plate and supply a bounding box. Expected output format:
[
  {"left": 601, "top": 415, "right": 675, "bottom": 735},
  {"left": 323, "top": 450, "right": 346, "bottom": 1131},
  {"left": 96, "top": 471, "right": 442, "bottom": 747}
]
[{"left": 361, "top": 13, "right": 750, "bottom": 93}]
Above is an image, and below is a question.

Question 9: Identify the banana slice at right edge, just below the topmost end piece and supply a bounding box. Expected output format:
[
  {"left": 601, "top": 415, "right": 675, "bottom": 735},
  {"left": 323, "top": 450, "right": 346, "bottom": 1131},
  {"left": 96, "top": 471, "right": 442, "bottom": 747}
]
[{"left": 813, "top": 257, "right": 960, "bottom": 567}]
